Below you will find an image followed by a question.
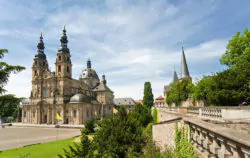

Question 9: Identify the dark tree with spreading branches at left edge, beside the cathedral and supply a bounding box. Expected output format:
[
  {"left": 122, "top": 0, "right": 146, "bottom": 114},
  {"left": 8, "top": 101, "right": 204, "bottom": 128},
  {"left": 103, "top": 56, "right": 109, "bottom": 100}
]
[{"left": 0, "top": 49, "right": 25, "bottom": 117}]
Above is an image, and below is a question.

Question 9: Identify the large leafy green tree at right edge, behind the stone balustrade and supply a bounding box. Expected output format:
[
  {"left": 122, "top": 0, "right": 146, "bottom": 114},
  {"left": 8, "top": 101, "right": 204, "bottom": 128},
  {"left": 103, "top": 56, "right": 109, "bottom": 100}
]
[{"left": 193, "top": 29, "right": 250, "bottom": 106}]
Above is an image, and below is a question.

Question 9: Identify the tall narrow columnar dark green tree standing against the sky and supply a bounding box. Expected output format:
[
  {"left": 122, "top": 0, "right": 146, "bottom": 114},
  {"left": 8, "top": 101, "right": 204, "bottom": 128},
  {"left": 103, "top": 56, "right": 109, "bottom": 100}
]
[{"left": 143, "top": 82, "right": 154, "bottom": 108}]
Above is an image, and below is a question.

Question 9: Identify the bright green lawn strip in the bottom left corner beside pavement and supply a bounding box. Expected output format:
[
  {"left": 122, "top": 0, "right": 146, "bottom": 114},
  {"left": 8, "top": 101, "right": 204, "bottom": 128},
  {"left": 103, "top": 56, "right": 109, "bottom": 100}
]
[{"left": 0, "top": 138, "right": 75, "bottom": 158}]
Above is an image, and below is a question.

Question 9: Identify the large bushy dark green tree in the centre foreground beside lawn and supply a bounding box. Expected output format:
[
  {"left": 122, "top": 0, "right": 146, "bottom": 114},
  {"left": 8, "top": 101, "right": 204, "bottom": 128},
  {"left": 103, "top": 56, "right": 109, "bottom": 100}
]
[{"left": 59, "top": 104, "right": 152, "bottom": 158}]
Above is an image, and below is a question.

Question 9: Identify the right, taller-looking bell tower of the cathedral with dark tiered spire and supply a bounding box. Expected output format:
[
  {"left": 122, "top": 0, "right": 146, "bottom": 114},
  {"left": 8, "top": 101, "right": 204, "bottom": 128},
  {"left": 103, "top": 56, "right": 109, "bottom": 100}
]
[{"left": 55, "top": 25, "right": 72, "bottom": 79}]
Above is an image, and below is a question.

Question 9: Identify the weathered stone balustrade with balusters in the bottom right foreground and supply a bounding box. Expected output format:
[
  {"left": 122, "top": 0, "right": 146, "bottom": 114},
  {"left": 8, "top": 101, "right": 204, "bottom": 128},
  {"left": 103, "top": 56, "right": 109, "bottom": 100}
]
[{"left": 184, "top": 118, "right": 250, "bottom": 158}]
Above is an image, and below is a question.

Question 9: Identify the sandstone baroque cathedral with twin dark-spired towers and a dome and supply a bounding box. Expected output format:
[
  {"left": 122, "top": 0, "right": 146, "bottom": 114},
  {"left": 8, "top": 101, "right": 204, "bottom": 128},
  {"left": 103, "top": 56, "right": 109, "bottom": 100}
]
[{"left": 22, "top": 26, "right": 114, "bottom": 125}]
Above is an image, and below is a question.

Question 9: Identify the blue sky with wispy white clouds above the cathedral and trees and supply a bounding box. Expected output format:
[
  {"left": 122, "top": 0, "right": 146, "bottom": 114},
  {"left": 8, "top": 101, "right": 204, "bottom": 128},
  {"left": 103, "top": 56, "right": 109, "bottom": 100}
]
[{"left": 0, "top": 0, "right": 250, "bottom": 99}]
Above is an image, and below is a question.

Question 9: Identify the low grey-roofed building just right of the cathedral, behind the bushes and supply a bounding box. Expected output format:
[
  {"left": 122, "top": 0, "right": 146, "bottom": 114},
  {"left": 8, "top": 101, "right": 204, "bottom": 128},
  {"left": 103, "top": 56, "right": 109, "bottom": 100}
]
[{"left": 114, "top": 98, "right": 136, "bottom": 112}]
